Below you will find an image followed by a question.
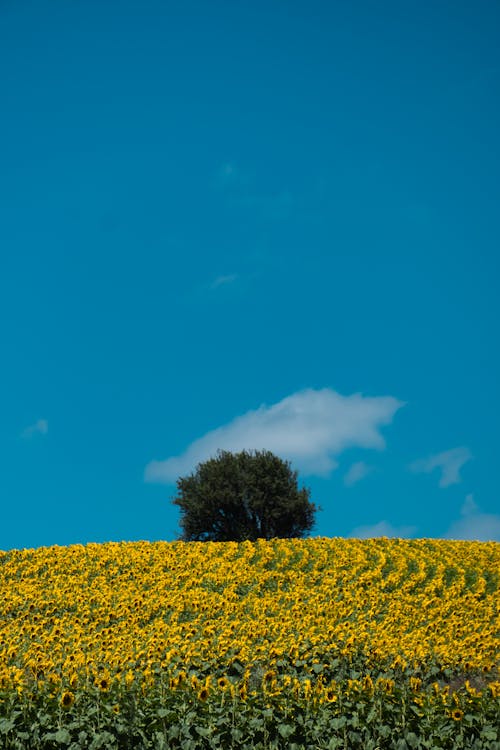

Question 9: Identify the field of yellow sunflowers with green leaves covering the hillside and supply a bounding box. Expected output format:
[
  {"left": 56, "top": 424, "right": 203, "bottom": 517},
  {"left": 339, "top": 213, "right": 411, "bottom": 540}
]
[{"left": 0, "top": 538, "right": 500, "bottom": 750}]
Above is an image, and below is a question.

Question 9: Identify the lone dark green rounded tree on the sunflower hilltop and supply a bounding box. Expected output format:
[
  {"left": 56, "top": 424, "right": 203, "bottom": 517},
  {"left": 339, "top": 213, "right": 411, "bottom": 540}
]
[{"left": 173, "top": 451, "right": 317, "bottom": 542}]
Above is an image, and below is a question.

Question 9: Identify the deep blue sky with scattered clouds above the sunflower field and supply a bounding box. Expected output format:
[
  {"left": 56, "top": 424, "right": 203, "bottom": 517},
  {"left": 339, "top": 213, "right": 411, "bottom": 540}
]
[{"left": 0, "top": 0, "right": 500, "bottom": 549}]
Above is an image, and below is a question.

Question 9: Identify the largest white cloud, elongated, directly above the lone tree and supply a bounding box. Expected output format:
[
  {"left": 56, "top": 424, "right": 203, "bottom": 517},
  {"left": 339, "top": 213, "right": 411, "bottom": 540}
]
[{"left": 145, "top": 388, "right": 404, "bottom": 483}]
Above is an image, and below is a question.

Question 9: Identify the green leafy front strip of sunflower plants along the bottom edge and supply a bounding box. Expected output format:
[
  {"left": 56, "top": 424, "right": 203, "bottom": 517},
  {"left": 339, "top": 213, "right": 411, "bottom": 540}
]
[{"left": 0, "top": 663, "right": 500, "bottom": 750}]
